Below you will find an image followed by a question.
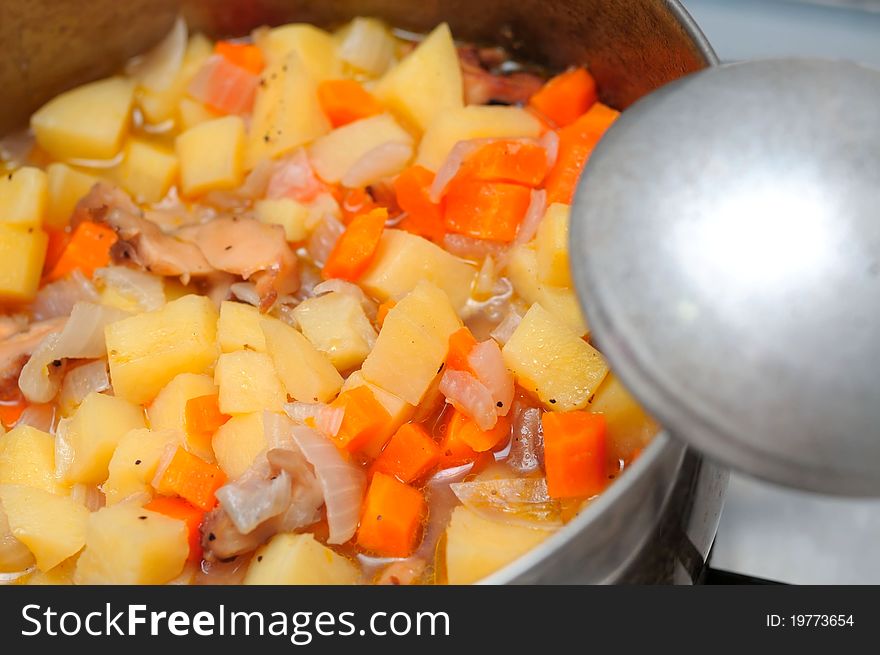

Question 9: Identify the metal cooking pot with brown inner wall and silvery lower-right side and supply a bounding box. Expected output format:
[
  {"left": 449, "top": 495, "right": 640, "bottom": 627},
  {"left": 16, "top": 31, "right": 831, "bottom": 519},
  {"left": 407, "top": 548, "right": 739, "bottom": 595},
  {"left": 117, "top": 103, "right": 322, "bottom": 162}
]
[{"left": 0, "top": 0, "right": 727, "bottom": 584}]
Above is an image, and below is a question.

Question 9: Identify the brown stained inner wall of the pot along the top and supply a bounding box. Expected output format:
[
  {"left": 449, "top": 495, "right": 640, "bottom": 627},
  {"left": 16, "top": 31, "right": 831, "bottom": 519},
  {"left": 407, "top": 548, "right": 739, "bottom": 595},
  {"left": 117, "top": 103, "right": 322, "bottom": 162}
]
[{"left": 0, "top": 0, "right": 714, "bottom": 134}]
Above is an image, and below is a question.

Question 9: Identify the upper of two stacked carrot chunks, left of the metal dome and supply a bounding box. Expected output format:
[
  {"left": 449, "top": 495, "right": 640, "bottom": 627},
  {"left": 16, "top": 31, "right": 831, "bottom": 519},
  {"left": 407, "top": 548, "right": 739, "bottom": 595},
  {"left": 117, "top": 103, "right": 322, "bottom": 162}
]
[{"left": 462, "top": 140, "right": 547, "bottom": 187}]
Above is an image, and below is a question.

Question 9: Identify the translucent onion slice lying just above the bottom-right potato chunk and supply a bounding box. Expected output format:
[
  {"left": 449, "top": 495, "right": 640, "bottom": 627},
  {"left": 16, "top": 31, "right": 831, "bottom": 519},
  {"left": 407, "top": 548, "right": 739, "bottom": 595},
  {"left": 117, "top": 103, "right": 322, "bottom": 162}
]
[{"left": 449, "top": 478, "right": 562, "bottom": 530}]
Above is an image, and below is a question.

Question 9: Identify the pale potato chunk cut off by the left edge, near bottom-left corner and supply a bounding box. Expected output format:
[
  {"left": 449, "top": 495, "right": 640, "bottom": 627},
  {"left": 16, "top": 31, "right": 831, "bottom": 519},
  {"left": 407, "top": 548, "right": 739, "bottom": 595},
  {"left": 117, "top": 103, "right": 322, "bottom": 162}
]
[{"left": 0, "top": 484, "right": 89, "bottom": 571}]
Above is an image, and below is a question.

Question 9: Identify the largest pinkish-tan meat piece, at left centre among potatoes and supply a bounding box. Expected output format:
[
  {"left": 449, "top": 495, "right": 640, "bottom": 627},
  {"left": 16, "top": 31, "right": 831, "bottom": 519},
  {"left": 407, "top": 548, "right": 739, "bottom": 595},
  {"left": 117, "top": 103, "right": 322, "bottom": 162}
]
[{"left": 177, "top": 216, "right": 299, "bottom": 311}]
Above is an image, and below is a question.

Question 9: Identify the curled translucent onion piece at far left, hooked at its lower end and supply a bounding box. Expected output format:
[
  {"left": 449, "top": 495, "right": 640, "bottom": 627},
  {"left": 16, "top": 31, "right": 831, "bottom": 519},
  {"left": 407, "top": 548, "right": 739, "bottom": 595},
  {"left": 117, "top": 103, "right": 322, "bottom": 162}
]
[{"left": 18, "top": 302, "right": 129, "bottom": 403}]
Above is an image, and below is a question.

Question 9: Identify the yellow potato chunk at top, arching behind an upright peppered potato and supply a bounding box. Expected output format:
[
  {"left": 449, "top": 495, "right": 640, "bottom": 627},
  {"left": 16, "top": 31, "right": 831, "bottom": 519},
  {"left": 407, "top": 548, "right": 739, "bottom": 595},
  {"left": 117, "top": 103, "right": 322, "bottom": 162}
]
[{"left": 257, "top": 23, "right": 342, "bottom": 82}]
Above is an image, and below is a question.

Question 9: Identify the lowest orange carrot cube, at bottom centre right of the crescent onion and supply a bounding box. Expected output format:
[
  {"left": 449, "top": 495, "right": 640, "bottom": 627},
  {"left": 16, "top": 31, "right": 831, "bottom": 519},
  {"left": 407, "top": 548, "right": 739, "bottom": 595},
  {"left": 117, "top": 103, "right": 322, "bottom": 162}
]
[{"left": 357, "top": 473, "right": 428, "bottom": 557}]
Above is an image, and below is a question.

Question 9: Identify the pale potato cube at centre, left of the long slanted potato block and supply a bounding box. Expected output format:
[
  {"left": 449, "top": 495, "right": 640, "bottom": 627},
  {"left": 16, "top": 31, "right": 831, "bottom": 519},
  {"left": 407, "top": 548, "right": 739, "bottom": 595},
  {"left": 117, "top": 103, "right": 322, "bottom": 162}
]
[{"left": 293, "top": 291, "right": 376, "bottom": 371}]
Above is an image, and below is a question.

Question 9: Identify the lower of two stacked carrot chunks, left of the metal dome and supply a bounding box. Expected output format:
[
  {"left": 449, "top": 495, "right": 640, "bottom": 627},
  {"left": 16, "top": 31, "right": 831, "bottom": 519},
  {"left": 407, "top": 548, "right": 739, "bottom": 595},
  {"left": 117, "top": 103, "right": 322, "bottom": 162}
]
[{"left": 443, "top": 174, "right": 532, "bottom": 241}]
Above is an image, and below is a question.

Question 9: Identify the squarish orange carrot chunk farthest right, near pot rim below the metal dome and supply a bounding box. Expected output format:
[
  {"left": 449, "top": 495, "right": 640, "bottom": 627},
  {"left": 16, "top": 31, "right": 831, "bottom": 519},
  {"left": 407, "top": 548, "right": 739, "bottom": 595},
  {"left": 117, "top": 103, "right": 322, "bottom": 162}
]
[{"left": 541, "top": 411, "right": 608, "bottom": 498}]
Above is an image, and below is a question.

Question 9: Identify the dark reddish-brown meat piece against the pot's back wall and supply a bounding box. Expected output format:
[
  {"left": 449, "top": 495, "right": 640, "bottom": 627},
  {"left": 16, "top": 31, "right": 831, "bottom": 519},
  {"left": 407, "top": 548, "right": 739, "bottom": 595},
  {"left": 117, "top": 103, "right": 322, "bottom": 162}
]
[{"left": 458, "top": 46, "right": 544, "bottom": 105}]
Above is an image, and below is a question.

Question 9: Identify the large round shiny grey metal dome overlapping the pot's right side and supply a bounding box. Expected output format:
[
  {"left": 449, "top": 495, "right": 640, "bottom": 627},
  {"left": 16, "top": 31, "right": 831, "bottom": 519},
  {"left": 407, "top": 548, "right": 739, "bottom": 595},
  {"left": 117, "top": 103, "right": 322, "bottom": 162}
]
[{"left": 572, "top": 60, "right": 880, "bottom": 495}]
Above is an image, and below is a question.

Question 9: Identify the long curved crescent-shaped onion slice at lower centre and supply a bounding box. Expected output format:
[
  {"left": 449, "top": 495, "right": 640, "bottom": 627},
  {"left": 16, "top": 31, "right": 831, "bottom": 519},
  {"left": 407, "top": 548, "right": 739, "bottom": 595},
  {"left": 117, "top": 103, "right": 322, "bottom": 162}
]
[{"left": 293, "top": 425, "right": 366, "bottom": 544}]
